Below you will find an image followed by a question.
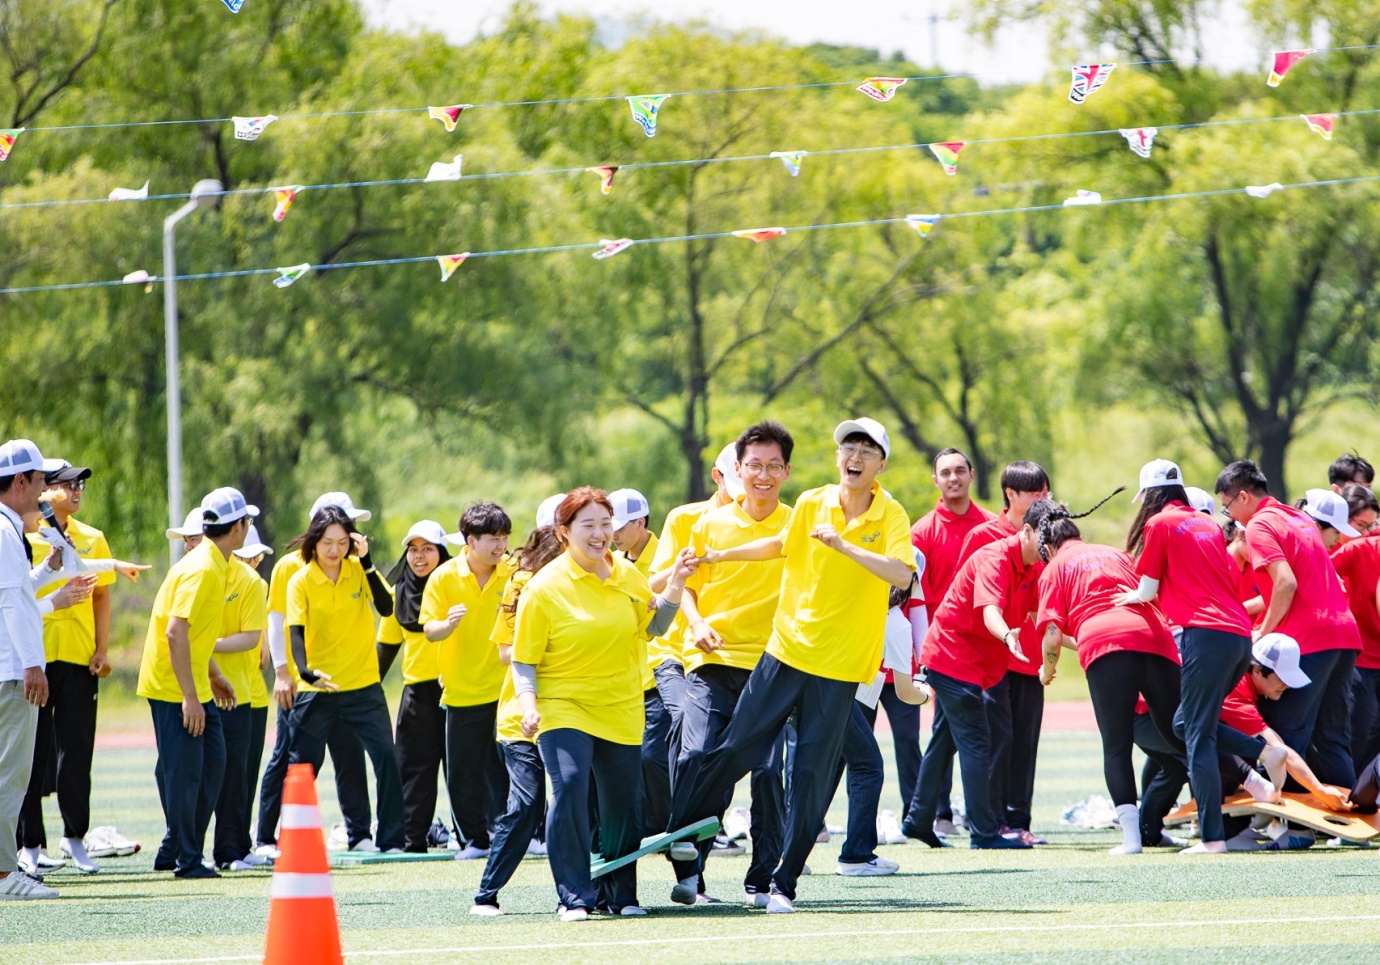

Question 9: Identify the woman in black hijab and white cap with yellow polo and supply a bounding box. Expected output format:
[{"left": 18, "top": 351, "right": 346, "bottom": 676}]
[{"left": 378, "top": 519, "right": 450, "bottom": 853}]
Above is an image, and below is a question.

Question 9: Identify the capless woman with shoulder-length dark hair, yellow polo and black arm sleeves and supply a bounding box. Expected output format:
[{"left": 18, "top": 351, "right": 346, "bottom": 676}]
[{"left": 287, "top": 507, "right": 403, "bottom": 852}]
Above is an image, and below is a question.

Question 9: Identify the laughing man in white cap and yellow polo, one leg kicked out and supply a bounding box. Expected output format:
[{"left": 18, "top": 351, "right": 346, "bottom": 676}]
[{"left": 669, "top": 418, "right": 915, "bottom": 914}]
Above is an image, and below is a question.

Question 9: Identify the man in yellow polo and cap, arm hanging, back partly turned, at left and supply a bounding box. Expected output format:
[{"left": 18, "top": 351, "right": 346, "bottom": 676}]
[{"left": 138, "top": 487, "right": 258, "bottom": 878}]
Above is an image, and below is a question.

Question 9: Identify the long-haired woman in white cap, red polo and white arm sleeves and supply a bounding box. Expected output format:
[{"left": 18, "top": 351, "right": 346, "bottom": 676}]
[{"left": 1116, "top": 460, "right": 1250, "bottom": 850}]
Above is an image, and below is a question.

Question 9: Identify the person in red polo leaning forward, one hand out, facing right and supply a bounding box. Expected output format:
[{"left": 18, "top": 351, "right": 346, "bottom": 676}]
[{"left": 901, "top": 526, "right": 1039, "bottom": 848}]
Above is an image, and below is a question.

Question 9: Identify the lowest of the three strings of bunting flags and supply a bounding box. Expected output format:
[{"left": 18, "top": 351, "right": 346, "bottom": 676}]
[{"left": 0, "top": 175, "right": 1380, "bottom": 294}]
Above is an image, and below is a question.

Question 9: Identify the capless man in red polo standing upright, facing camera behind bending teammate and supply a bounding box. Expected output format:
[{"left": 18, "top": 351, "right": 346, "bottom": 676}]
[{"left": 905, "top": 447, "right": 995, "bottom": 835}]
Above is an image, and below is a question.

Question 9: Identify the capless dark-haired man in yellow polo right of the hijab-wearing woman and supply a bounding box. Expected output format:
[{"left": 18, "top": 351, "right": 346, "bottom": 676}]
[{"left": 420, "top": 503, "right": 513, "bottom": 861}]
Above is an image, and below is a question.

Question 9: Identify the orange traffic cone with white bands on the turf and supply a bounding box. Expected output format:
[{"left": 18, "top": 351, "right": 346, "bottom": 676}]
[{"left": 264, "top": 763, "right": 344, "bottom": 965}]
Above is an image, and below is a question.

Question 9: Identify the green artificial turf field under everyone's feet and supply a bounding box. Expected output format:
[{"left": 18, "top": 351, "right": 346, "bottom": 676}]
[{"left": 0, "top": 732, "right": 1380, "bottom": 965}]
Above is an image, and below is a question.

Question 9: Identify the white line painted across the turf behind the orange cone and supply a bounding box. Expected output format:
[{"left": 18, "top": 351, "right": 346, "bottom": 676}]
[{"left": 53, "top": 915, "right": 1380, "bottom": 965}]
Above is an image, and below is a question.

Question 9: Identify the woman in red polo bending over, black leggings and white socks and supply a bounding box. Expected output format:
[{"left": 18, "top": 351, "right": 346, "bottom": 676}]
[{"left": 1025, "top": 500, "right": 1181, "bottom": 855}]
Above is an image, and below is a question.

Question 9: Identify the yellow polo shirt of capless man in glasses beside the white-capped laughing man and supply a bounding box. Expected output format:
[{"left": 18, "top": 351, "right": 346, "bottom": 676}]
[{"left": 684, "top": 496, "right": 791, "bottom": 671}]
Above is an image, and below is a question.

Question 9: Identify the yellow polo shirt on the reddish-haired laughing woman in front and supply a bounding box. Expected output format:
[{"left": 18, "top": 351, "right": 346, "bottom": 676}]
[{"left": 513, "top": 552, "right": 653, "bottom": 745}]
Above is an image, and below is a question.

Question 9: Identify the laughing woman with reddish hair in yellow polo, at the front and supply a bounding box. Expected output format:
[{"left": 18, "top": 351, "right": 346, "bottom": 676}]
[{"left": 512, "top": 486, "right": 694, "bottom": 921}]
